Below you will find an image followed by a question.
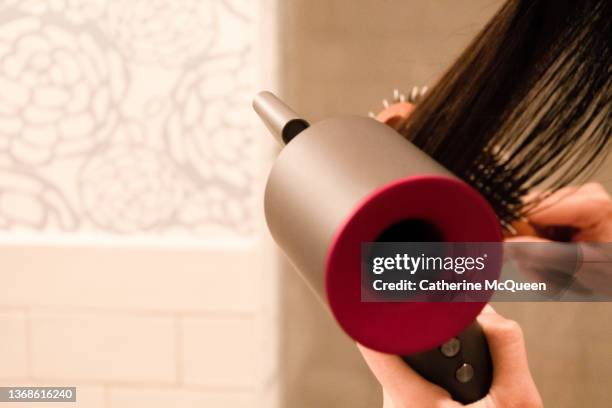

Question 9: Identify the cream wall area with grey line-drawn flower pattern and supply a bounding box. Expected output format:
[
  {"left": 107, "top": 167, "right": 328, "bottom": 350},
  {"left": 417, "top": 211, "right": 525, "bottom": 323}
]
[{"left": 0, "top": 0, "right": 257, "bottom": 237}]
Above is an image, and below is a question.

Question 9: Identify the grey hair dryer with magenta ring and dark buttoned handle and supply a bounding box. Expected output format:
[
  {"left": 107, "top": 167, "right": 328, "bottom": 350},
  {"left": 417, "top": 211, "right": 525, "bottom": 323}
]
[{"left": 253, "top": 92, "right": 502, "bottom": 403}]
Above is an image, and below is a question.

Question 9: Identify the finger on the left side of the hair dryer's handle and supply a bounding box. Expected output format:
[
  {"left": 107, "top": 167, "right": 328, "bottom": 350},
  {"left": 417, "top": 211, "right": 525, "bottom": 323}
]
[{"left": 357, "top": 344, "right": 450, "bottom": 401}]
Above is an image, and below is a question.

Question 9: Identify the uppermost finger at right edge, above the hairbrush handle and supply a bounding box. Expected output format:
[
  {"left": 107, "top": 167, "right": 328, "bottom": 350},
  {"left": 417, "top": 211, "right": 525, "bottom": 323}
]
[{"left": 528, "top": 183, "right": 610, "bottom": 228}]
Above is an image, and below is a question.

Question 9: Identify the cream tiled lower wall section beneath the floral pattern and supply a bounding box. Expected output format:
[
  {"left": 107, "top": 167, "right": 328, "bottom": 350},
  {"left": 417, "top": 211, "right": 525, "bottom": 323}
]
[{"left": 0, "top": 245, "right": 277, "bottom": 408}]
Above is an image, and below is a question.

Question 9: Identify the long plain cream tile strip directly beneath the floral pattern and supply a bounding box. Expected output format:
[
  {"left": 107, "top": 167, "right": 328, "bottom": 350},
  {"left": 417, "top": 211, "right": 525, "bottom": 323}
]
[{"left": 0, "top": 245, "right": 262, "bottom": 313}]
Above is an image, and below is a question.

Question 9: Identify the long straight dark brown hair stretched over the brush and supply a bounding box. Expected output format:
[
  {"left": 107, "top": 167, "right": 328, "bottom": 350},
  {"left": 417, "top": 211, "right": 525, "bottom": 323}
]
[{"left": 400, "top": 0, "right": 612, "bottom": 225}]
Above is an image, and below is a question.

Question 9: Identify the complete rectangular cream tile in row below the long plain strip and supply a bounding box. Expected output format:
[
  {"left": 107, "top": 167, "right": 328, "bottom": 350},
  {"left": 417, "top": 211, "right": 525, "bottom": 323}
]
[{"left": 31, "top": 311, "right": 176, "bottom": 382}]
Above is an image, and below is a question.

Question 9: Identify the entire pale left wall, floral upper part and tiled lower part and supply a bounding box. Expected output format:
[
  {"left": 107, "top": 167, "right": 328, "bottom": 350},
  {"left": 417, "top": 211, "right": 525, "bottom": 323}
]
[{"left": 0, "top": 0, "right": 277, "bottom": 408}]
